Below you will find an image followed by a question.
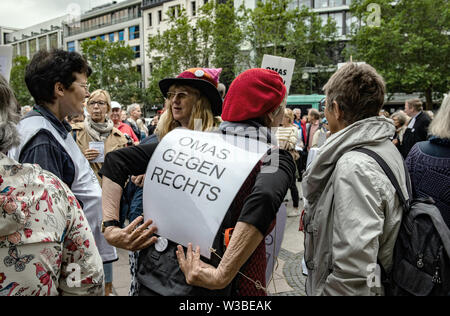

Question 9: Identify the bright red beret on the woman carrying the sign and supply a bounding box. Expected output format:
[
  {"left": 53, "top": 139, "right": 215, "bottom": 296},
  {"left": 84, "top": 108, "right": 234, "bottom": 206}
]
[{"left": 222, "top": 68, "right": 286, "bottom": 122}]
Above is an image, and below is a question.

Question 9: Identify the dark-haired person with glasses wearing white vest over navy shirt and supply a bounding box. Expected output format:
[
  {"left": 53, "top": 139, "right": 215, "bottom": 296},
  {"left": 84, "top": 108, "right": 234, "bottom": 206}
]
[{"left": 8, "top": 49, "right": 117, "bottom": 268}]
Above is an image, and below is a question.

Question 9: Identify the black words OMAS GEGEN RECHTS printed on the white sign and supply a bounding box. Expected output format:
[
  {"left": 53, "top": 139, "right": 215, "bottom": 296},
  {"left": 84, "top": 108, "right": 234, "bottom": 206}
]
[{"left": 151, "top": 137, "right": 230, "bottom": 202}]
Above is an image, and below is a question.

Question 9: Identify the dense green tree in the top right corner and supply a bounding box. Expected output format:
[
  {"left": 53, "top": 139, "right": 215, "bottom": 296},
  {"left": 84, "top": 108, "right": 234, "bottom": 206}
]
[{"left": 350, "top": 0, "right": 450, "bottom": 109}]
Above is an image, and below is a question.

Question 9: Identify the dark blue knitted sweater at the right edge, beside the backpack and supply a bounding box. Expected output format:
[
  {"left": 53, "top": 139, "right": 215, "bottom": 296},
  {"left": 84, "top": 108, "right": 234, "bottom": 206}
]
[{"left": 406, "top": 137, "right": 450, "bottom": 227}]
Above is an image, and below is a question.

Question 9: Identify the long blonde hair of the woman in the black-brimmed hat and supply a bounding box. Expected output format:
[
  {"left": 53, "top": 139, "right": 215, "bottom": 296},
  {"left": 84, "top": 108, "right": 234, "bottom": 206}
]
[{"left": 155, "top": 85, "right": 220, "bottom": 140}]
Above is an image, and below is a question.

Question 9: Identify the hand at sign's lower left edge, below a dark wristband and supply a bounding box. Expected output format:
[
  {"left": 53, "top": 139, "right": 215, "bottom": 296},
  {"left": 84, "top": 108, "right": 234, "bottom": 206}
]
[{"left": 104, "top": 216, "right": 157, "bottom": 251}]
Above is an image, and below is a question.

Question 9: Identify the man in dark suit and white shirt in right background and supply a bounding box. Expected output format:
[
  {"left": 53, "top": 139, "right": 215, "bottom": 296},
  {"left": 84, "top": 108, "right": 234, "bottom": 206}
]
[{"left": 400, "top": 99, "right": 431, "bottom": 159}]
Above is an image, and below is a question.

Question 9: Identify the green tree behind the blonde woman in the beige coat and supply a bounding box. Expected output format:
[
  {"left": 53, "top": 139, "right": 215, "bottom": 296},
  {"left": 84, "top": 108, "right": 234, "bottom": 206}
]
[{"left": 81, "top": 38, "right": 145, "bottom": 105}]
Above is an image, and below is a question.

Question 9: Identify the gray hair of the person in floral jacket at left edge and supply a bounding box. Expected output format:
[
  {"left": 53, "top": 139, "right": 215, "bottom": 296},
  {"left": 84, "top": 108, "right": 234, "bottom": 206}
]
[{"left": 0, "top": 74, "right": 20, "bottom": 153}]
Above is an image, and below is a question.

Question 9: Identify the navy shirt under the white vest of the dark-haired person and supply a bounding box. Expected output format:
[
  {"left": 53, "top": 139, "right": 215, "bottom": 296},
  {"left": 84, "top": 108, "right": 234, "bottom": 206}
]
[{"left": 19, "top": 105, "right": 75, "bottom": 188}]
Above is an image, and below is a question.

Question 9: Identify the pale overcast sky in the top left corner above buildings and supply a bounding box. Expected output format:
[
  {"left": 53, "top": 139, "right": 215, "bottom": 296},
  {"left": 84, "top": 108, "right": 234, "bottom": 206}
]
[{"left": 0, "top": 0, "right": 124, "bottom": 28}]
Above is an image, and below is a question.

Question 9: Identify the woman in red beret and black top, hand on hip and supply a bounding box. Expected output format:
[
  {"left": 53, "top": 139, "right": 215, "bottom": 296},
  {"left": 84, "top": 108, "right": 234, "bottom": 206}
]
[{"left": 177, "top": 69, "right": 295, "bottom": 296}]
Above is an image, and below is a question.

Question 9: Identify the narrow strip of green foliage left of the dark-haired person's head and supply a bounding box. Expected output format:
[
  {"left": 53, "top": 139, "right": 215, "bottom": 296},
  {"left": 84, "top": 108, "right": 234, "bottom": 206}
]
[{"left": 10, "top": 56, "right": 34, "bottom": 106}]
